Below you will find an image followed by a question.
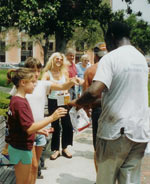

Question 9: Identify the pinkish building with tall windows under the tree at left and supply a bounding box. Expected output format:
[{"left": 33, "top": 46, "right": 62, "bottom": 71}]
[{"left": 0, "top": 29, "right": 55, "bottom": 64}]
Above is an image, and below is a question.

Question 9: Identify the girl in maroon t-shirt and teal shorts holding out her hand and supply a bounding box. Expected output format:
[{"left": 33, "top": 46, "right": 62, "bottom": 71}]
[{"left": 6, "top": 68, "right": 67, "bottom": 184}]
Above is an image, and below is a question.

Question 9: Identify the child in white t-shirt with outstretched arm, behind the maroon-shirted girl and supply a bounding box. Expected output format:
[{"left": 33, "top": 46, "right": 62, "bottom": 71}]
[{"left": 4, "top": 57, "right": 76, "bottom": 184}]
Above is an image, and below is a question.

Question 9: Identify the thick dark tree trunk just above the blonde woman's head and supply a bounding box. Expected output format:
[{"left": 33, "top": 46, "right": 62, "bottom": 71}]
[{"left": 55, "top": 31, "right": 67, "bottom": 53}]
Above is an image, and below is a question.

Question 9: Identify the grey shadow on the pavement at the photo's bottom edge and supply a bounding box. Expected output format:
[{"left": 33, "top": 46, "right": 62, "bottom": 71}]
[{"left": 57, "top": 173, "right": 94, "bottom": 184}]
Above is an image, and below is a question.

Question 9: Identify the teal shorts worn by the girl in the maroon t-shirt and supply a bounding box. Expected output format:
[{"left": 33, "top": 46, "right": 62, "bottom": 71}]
[{"left": 8, "top": 145, "right": 32, "bottom": 165}]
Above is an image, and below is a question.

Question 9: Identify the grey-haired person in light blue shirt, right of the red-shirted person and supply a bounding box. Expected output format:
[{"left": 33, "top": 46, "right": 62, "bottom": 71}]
[{"left": 75, "top": 54, "right": 90, "bottom": 98}]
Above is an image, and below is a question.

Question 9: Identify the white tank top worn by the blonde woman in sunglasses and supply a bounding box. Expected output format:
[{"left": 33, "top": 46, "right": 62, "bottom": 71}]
[{"left": 48, "top": 71, "right": 66, "bottom": 99}]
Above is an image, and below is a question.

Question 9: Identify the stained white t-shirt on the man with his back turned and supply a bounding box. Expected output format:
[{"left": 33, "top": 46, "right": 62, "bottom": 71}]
[{"left": 93, "top": 45, "right": 150, "bottom": 142}]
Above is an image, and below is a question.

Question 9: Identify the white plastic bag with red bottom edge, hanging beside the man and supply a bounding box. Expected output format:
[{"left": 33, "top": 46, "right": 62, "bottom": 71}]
[{"left": 69, "top": 107, "right": 91, "bottom": 132}]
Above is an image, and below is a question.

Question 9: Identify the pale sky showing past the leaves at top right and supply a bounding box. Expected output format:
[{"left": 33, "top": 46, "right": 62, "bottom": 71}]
[{"left": 112, "top": 0, "right": 150, "bottom": 23}]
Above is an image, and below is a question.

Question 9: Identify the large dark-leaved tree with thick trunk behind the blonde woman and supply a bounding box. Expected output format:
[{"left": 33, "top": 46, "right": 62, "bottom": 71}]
[{"left": 0, "top": 0, "right": 110, "bottom": 61}]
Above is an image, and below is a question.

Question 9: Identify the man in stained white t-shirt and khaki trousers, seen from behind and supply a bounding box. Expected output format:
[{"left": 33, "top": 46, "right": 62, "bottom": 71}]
[{"left": 72, "top": 22, "right": 150, "bottom": 184}]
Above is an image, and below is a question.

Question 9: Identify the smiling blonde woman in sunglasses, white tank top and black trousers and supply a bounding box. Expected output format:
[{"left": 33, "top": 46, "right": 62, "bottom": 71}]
[{"left": 42, "top": 52, "right": 73, "bottom": 160}]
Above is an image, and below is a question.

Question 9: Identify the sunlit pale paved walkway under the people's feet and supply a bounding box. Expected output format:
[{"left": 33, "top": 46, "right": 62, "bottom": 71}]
[{"left": 36, "top": 128, "right": 150, "bottom": 184}]
